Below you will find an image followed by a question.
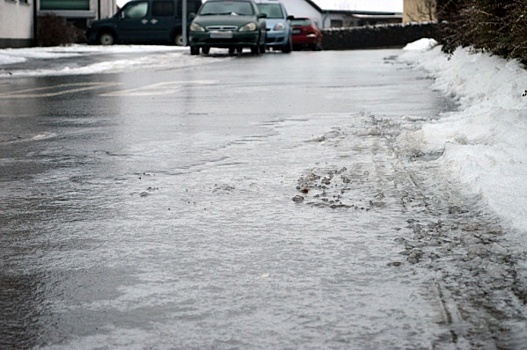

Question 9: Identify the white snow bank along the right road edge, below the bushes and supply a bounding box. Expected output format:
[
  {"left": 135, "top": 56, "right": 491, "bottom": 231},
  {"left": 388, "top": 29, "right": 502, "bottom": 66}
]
[{"left": 399, "top": 40, "right": 527, "bottom": 233}]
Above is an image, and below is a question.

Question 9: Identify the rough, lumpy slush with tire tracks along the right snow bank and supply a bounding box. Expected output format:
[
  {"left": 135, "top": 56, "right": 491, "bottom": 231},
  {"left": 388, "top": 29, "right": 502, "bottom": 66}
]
[{"left": 293, "top": 116, "right": 527, "bottom": 349}]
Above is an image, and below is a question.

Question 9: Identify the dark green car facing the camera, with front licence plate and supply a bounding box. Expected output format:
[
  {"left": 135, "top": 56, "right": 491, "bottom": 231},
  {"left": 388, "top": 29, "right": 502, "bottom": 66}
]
[{"left": 189, "top": 0, "right": 266, "bottom": 55}]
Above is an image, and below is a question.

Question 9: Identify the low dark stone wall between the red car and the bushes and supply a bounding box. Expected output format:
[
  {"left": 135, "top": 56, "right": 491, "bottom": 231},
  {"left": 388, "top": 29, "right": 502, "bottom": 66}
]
[{"left": 322, "top": 23, "right": 439, "bottom": 50}]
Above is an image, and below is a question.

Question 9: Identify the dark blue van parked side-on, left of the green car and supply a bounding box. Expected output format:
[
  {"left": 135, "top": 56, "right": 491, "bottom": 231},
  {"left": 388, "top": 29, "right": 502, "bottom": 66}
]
[{"left": 86, "top": 0, "right": 201, "bottom": 45}]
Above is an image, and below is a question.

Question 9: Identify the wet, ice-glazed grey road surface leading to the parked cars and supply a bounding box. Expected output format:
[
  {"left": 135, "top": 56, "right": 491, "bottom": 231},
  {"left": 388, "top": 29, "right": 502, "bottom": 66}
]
[{"left": 0, "top": 50, "right": 526, "bottom": 349}]
